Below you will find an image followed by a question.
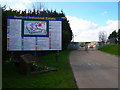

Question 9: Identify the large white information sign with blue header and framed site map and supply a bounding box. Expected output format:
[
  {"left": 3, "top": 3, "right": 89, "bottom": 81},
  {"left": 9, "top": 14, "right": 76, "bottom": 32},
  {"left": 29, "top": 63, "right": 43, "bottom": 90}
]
[{"left": 7, "top": 15, "right": 62, "bottom": 51}]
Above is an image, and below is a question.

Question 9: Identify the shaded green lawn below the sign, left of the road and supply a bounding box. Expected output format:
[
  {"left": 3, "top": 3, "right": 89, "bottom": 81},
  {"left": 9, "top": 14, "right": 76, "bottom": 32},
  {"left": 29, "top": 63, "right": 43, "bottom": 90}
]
[{"left": 2, "top": 50, "right": 75, "bottom": 88}]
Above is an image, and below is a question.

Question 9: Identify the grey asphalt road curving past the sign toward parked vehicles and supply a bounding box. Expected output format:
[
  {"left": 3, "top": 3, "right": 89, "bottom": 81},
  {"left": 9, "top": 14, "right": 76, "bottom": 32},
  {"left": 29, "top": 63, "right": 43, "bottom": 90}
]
[{"left": 69, "top": 48, "right": 118, "bottom": 88}]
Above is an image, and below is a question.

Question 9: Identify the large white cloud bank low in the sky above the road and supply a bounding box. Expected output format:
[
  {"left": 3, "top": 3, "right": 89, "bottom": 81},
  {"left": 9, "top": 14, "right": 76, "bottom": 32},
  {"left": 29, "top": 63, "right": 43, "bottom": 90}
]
[{"left": 66, "top": 15, "right": 118, "bottom": 42}]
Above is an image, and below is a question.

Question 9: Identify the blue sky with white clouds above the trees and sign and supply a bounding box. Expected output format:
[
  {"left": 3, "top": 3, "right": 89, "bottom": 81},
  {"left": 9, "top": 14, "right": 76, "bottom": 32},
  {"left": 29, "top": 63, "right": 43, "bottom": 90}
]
[{"left": 0, "top": 0, "right": 118, "bottom": 42}]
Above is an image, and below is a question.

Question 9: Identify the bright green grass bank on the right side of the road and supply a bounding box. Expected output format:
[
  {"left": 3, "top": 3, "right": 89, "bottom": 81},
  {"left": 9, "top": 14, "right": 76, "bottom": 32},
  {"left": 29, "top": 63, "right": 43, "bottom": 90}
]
[{"left": 98, "top": 44, "right": 120, "bottom": 55}]
